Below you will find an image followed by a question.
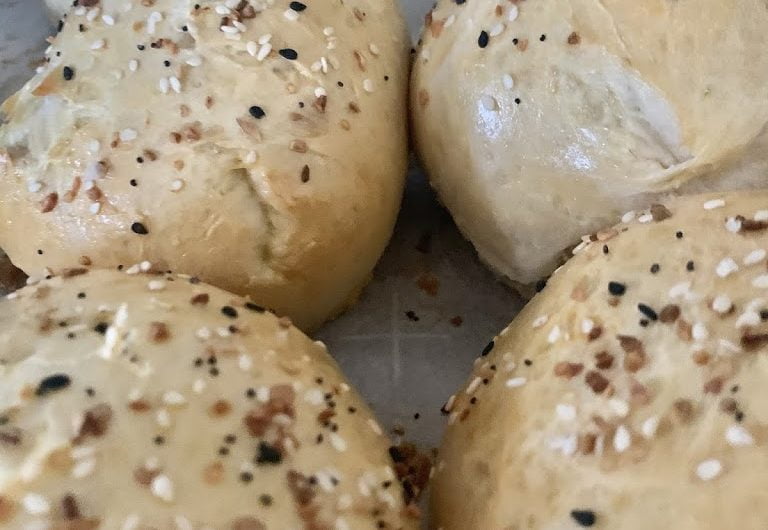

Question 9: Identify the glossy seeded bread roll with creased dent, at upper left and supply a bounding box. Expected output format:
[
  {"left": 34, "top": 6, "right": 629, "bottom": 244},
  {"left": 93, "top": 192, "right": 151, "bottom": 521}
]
[{"left": 0, "top": 0, "right": 409, "bottom": 329}]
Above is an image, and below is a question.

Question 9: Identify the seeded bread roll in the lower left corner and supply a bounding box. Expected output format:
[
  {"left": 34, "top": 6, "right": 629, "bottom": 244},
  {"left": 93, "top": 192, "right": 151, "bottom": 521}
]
[{"left": 0, "top": 268, "right": 418, "bottom": 530}]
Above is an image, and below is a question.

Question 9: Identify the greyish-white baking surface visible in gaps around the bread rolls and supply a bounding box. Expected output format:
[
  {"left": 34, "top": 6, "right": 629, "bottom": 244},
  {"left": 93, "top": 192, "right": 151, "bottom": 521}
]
[{"left": 0, "top": 0, "right": 521, "bottom": 484}]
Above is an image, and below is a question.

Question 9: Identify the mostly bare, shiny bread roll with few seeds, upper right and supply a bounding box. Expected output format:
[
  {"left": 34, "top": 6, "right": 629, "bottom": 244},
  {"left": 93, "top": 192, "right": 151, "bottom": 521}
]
[{"left": 412, "top": 0, "right": 768, "bottom": 284}]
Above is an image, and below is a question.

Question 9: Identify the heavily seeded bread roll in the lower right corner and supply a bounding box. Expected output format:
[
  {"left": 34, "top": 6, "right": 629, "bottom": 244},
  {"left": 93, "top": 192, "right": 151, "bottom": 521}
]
[{"left": 432, "top": 191, "right": 768, "bottom": 530}]
